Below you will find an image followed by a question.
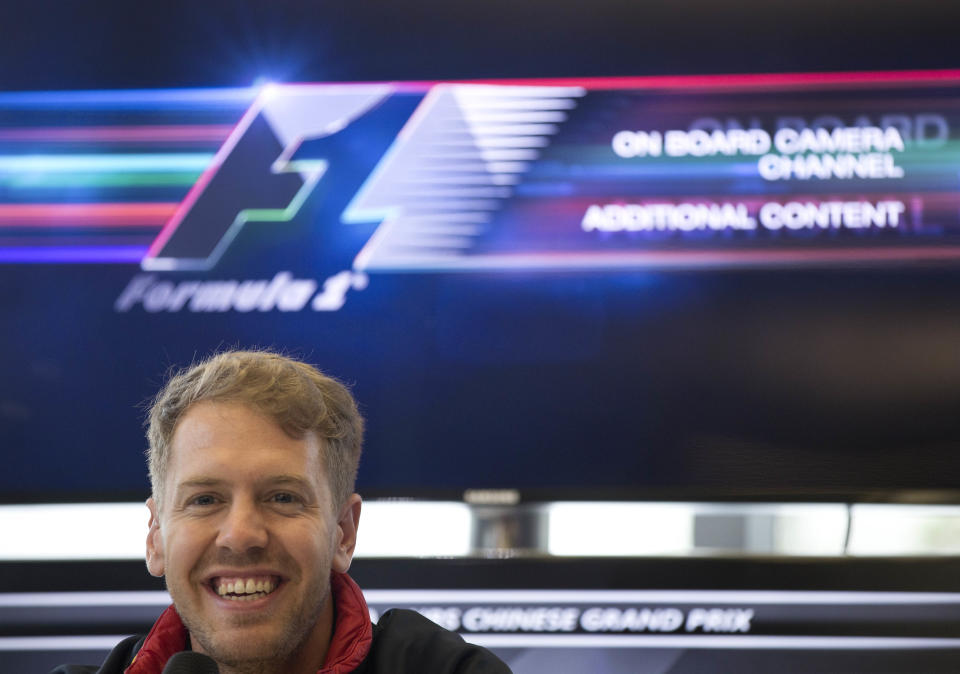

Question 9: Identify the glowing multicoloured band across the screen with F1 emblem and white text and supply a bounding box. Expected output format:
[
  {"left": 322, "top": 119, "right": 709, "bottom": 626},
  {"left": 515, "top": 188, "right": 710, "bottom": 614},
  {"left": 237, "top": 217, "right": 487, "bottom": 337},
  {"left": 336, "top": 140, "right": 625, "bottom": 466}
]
[{"left": 0, "top": 73, "right": 960, "bottom": 271}]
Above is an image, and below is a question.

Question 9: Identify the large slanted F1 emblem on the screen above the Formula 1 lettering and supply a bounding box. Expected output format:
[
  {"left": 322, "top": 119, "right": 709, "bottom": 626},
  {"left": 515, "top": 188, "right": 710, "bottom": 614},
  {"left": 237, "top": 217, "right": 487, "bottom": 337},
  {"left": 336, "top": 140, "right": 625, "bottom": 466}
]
[{"left": 141, "top": 84, "right": 584, "bottom": 271}]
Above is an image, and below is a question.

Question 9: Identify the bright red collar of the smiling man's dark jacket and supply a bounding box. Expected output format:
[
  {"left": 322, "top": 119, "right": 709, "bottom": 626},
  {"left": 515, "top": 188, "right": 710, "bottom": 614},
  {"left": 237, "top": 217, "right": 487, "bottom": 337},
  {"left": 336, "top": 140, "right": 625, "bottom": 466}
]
[{"left": 125, "top": 573, "right": 373, "bottom": 674}]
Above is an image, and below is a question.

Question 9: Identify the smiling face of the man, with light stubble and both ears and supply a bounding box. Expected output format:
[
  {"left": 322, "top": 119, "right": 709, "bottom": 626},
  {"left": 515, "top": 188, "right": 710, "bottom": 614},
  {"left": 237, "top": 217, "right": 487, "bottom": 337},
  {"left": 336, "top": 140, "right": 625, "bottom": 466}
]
[{"left": 147, "top": 402, "right": 360, "bottom": 668}]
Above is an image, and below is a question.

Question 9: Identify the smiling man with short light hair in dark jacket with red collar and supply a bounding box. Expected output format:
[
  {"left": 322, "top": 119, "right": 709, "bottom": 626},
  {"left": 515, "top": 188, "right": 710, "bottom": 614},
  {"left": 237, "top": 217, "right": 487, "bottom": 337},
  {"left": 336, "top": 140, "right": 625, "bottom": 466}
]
[{"left": 55, "top": 351, "right": 509, "bottom": 674}]
